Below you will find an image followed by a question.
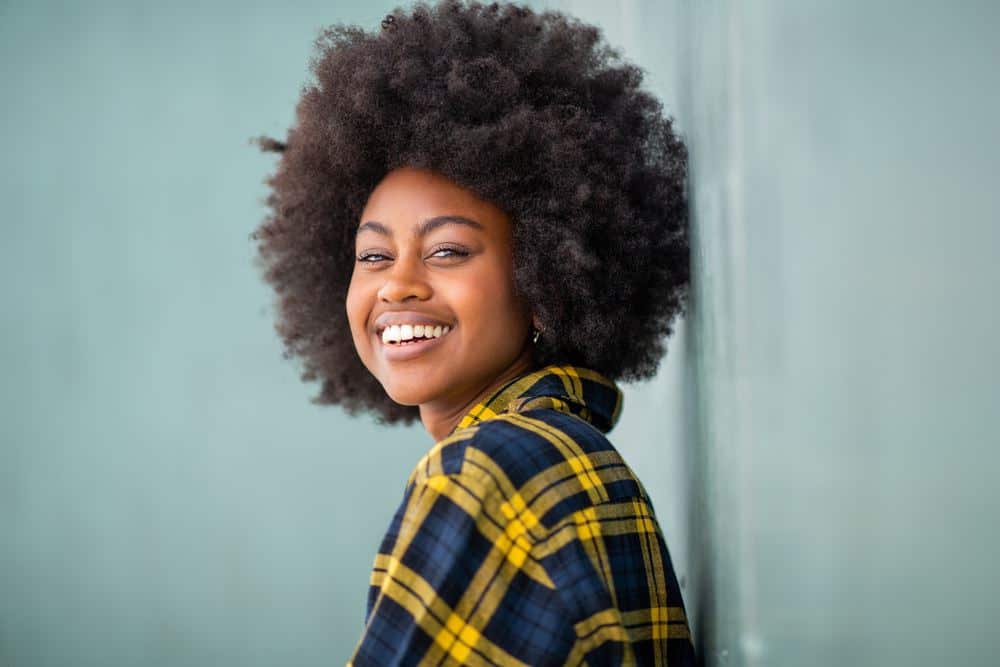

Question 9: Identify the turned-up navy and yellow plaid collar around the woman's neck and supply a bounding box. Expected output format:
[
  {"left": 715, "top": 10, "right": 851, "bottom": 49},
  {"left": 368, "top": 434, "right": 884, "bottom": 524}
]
[{"left": 452, "top": 365, "right": 622, "bottom": 433}]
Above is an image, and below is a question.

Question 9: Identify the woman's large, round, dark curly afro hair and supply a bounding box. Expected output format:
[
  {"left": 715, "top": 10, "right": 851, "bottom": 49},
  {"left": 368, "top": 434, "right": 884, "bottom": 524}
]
[{"left": 251, "top": 0, "right": 689, "bottom": 423}]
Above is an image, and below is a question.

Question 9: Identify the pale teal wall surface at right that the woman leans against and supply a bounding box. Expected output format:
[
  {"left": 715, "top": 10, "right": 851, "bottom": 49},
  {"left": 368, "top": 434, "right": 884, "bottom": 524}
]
[{"left": 553, "top": 0, "right": 1000, "bottom": 665}]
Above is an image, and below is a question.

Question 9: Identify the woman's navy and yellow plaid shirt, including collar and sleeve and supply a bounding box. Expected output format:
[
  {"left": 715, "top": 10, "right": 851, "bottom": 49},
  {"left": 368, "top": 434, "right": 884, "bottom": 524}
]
[{"left": 348, "top": 366, "right": 695, "bottom": 667}]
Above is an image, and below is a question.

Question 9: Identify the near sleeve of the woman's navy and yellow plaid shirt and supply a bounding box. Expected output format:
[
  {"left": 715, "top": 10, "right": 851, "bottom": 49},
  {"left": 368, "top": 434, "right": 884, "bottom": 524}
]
[{"left": 348, "top": 475, "right": 576, "bottom": 667}]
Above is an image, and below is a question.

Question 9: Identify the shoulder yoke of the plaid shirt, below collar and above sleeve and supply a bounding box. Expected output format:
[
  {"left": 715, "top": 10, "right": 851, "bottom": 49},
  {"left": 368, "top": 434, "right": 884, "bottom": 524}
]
[{"left": 410, "top": 408, "right": 646, "bottom": 528}]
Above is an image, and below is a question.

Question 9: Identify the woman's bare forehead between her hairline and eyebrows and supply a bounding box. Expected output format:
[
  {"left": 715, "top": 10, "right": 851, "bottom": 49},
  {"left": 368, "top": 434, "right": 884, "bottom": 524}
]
[{"left": 359, "top": 167, "right": 510, "bottom": 235}]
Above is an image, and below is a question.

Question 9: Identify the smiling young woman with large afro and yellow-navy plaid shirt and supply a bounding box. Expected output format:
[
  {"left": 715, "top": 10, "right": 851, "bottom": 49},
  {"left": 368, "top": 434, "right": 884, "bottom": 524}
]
[{"left": 255, "top": 0, "right": 694, "bottom": 666}]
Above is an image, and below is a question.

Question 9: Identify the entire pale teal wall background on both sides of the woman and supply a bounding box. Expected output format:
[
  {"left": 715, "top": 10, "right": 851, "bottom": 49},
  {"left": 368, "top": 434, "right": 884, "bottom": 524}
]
[{"left": 0, "top": 0, "right": 1000, "bottom": 667}]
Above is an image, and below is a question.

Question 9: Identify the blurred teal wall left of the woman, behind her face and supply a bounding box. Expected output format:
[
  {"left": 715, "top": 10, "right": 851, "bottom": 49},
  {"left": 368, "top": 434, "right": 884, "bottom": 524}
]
[{"left": 0, "top": 1, "right": 422, "bottom": 667}]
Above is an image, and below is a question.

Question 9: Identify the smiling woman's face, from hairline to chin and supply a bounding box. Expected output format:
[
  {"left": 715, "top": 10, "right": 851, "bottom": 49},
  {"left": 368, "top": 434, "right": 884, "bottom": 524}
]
[{"left": 347, "top": 168, "right": 530, "bottom": 414}]
